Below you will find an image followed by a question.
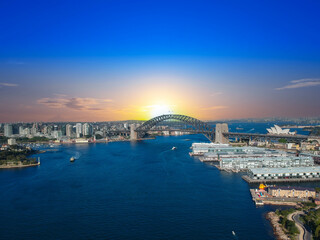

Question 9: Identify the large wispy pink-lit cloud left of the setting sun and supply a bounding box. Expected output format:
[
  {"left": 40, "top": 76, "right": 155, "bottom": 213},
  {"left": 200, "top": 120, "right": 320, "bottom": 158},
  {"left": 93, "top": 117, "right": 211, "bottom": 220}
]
[{"left": 37, "top": 94, "right": 112, "bottom": 111}]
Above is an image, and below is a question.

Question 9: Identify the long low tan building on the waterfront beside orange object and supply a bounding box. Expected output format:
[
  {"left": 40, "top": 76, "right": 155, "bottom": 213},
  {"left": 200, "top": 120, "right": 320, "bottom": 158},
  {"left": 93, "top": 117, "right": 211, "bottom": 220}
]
[{"left": 268, "top": 186, "right": 316, "bottom": 198}]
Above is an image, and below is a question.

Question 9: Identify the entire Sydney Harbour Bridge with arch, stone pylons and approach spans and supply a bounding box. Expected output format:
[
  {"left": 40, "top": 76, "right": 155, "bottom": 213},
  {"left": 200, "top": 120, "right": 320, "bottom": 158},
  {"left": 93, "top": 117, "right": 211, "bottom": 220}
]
[{"left": 107, "top": 114, "right": 308, "bottom": 143}]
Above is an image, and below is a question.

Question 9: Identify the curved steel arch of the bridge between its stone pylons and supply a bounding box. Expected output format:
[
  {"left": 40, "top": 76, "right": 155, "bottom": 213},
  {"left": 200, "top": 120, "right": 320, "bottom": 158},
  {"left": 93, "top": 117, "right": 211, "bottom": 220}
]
[{"left": 135, "top": 114, "right": 215, "bottom": 141}]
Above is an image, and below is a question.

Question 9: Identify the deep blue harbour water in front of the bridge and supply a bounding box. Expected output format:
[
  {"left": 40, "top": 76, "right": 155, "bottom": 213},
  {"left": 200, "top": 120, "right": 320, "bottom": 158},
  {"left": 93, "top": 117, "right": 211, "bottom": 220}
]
[{"left": 0, "top": 135, "right": 280, "bottom": 240}]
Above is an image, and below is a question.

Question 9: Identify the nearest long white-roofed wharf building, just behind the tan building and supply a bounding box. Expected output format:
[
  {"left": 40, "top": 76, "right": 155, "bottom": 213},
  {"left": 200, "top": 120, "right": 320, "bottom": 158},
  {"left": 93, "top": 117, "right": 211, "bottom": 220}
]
[{"left": 245, "top": 166, "right": 320, "bottom": 182}]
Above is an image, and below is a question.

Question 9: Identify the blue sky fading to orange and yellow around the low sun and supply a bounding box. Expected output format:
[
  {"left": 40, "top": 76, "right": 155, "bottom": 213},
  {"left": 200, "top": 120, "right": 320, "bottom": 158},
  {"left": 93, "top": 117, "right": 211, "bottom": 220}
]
[{"left": 0, "top": 0, "right": 320, "bottom": 122}]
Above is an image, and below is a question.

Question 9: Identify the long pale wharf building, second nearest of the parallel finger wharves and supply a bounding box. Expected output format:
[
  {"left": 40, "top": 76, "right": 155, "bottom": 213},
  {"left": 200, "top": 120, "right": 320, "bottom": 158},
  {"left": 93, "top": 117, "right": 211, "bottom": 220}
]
[{"left": 220, "top": 156, "right": 314, "bottom": 171}]
